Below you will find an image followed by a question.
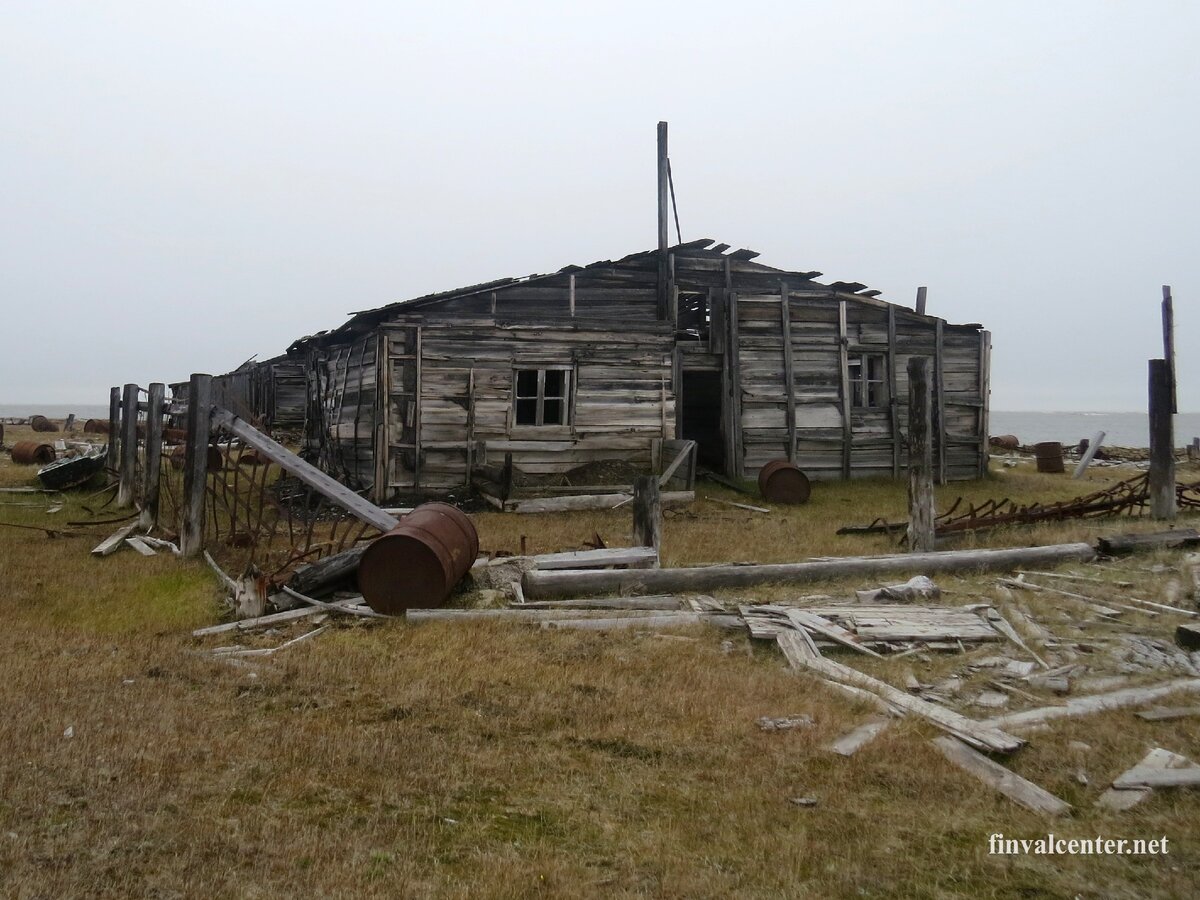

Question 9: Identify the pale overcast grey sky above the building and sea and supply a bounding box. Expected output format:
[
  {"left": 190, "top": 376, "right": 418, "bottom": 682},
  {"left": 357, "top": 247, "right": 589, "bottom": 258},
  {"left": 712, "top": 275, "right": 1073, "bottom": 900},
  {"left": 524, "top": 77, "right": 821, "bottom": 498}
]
[{"left": 0, "top": 0, "right": 1200, "bottom": 410}]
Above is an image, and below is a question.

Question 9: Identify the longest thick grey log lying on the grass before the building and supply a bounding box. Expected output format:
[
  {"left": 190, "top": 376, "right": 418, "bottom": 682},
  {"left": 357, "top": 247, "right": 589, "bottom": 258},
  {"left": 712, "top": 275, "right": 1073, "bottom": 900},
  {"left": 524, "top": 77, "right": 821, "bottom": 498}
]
[{"left": 524, "top": 544, "right": 1096, "bottom": 599}]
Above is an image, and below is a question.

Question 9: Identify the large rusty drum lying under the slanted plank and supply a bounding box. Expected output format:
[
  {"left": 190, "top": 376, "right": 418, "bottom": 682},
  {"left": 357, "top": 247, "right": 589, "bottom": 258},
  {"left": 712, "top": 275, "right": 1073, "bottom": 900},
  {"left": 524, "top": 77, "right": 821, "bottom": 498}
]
[{"left": 358, "top": 503, "right": 479, "bottom": 614}]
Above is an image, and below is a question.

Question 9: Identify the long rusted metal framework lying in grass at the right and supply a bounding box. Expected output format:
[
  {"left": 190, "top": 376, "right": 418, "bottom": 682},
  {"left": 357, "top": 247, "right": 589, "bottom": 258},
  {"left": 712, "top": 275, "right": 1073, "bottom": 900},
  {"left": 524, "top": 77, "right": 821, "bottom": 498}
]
[{"left": 838, "top": 473, "right": 1200, "bottom": 535}]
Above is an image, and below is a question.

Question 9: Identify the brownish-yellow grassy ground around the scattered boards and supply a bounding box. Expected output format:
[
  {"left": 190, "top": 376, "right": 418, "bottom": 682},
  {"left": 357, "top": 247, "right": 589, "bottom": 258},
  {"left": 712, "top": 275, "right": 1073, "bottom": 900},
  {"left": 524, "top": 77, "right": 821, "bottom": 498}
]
[{"left": 0, "top": 428, "right": 1200, "bottom": 898}]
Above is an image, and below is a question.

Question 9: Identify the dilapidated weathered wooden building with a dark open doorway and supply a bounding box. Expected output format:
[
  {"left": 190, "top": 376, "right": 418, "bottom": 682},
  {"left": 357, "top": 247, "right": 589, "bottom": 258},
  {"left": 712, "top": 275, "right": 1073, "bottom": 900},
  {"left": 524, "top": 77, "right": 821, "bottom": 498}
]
[{"left": 235, "top": 240, "right": 989, "bottom": 502}]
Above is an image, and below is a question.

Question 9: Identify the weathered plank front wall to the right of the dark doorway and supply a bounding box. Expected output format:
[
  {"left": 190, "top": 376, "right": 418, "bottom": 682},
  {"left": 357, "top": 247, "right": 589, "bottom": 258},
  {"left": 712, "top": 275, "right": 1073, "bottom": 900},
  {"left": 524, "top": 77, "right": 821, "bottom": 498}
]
[{"left": 737, "top": 290, "right": 986, "bottom": 480}]
